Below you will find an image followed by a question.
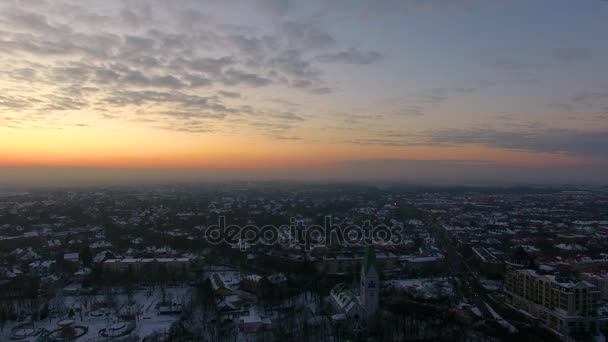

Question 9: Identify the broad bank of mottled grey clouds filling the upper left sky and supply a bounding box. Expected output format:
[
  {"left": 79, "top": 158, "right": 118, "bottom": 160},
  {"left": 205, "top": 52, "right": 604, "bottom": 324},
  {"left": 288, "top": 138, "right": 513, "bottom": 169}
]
[{"left": 0, "top": 0, "right": 381, "bottom": 138}]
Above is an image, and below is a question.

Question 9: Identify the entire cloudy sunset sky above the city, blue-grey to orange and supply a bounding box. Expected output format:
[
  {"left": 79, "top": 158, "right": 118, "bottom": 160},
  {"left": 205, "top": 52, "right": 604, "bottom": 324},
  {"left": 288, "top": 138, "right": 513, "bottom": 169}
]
[{"left": 0, "top": 0, "right": 608, "bottom": 183}]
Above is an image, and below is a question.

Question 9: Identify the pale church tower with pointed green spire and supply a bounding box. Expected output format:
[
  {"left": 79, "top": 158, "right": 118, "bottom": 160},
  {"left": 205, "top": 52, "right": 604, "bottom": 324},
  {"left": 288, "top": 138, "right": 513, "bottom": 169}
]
[{"left": 360, "top": 244, "right": 380, "bottom": 317}]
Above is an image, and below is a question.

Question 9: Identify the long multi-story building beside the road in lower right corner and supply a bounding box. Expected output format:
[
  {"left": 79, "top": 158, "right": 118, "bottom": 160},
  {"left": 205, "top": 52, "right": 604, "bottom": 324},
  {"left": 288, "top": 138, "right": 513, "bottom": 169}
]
[{"left": 505, "top": 269, "right": 600, "bottom": 336}]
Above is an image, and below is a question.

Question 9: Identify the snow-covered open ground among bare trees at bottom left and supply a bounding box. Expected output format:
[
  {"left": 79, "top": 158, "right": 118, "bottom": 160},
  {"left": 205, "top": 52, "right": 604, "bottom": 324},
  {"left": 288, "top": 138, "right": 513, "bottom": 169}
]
[{"left": 0, "top": 286, "right": 191, "bottom": 341}]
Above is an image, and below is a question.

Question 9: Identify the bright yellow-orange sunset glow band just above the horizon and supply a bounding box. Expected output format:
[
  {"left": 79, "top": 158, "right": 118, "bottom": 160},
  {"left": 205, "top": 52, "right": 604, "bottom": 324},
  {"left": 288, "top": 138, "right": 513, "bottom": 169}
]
[{"left": 0, "top": 124, "right": 596, "bottom": 170}]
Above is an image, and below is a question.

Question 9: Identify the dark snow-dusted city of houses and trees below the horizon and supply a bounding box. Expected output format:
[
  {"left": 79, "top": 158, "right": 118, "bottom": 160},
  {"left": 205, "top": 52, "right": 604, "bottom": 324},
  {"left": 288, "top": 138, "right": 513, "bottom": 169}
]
[{"left": 0, "top": 183, "right": 608, "bottom": 341}]
